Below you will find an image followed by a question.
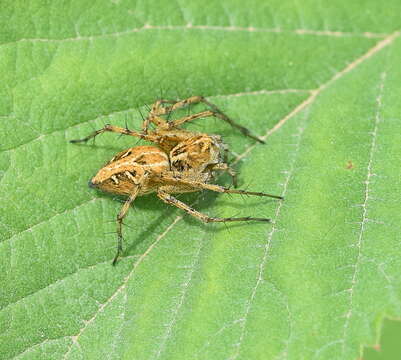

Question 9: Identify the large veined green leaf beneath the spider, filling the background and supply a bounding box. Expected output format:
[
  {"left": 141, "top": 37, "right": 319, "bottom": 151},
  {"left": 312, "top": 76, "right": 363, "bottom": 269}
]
[{"left": 0, "top": 0, "right": 401, "bottom": 359}]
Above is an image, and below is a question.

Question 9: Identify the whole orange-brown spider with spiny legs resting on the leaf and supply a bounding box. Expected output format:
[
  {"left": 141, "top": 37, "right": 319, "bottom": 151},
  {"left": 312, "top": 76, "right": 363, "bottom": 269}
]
[{"left": 70, "top": 96, "right": 283, "bottom": 265}]
